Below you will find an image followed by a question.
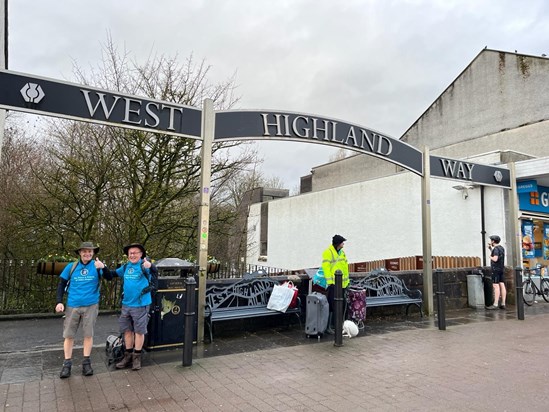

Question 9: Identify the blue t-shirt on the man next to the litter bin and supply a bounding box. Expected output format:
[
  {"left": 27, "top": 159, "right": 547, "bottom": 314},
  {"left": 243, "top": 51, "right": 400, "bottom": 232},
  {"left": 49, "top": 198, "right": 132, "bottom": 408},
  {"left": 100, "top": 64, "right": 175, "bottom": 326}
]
[{"left": 116, "top": 259, "right": 152, "bottom": 307}]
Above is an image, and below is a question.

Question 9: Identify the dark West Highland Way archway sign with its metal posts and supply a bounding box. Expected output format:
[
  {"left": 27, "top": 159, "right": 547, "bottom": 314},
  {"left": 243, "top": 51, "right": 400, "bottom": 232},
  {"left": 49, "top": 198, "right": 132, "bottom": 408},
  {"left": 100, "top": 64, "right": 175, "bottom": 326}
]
[{"left": 0, "top": 70, "right": 511, "bottom": 332}]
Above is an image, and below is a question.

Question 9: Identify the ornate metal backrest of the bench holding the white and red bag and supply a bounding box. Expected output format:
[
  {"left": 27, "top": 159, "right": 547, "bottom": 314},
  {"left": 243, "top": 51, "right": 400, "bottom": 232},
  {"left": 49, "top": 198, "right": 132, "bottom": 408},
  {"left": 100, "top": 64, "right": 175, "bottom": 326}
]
[{"left": 206, "top": 278, "right": 278, "bottom": 310}]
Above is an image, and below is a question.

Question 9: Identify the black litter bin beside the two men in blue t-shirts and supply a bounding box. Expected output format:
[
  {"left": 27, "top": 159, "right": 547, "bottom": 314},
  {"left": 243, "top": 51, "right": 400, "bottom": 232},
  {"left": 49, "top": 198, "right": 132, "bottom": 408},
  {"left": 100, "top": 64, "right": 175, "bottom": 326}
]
[{"left": 145, "top": 258, "right": 198, "bottom": 351}]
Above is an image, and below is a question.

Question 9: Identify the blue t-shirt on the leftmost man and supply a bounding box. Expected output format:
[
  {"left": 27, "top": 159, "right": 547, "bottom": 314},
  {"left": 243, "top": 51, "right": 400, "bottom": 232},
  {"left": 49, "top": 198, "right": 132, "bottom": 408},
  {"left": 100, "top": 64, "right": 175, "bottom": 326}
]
[{"left": 60, "top": 260, "right": 100, "bottom": 308}]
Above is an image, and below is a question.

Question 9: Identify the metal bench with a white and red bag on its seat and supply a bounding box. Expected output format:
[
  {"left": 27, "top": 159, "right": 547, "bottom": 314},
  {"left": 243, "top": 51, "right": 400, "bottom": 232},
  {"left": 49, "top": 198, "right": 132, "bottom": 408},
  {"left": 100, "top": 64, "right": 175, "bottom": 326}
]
[{"left": 205, "top": 277, "right": 301, "bottom": 342}]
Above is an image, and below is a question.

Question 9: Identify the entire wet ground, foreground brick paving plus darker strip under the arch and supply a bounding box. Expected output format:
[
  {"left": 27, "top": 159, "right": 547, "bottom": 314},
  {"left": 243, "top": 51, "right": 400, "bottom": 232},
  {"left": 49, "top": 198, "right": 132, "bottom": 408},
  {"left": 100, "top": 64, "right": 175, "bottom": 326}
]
[{"left": 0, "top": 302, "right": 549, "bottom": 411}]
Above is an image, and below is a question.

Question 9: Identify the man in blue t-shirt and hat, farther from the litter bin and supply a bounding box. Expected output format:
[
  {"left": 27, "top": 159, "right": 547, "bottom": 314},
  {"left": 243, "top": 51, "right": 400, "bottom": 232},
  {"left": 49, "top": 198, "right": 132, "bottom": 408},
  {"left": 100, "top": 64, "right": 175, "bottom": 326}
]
[{"left": 55, "top": 242, "right": 103, "bottom": 379}]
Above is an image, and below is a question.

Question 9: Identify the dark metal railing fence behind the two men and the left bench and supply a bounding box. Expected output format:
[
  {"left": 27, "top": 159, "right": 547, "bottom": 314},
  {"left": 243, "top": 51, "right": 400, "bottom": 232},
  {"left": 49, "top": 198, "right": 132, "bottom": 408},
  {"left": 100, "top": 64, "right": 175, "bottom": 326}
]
[{"left": 0, "top": 259, "right": 290, "bottom": 315}]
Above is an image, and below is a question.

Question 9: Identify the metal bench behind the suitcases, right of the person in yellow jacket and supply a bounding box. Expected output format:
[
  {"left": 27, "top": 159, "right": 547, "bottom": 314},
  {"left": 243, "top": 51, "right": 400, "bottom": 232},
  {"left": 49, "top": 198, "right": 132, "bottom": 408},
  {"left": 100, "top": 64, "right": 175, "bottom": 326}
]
[{"left": 350, "top": 270, "right": 423, "bottom": 317}]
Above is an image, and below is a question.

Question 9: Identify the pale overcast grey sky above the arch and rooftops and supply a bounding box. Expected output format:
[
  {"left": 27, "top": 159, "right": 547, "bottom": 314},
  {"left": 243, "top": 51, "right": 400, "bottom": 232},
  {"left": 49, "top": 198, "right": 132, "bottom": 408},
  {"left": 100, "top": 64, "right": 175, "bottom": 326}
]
[{"left": 8, "top": 0, "right": 549, "bottom": 189}]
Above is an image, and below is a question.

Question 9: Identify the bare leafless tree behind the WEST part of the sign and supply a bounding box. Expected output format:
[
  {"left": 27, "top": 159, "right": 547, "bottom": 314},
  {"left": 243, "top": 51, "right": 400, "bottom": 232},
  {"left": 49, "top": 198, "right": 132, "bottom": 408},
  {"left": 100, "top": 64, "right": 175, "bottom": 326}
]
[{"left": 4, "top": 39, "right": 257, "bottom": 257}]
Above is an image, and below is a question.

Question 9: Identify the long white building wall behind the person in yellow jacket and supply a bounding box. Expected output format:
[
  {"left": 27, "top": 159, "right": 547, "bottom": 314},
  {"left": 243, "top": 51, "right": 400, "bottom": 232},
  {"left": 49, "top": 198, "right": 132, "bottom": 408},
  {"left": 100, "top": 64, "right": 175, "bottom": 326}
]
[{"left": 248, "top": 172, "right": 505, "bottom": 270}]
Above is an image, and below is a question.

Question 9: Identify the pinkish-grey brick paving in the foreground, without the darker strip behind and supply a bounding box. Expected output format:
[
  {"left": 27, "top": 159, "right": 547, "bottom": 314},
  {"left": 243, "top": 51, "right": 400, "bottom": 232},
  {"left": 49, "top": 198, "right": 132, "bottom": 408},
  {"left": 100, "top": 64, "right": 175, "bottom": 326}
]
[{"left": 0, "top": 303, "right": 549, "bottom": 412}]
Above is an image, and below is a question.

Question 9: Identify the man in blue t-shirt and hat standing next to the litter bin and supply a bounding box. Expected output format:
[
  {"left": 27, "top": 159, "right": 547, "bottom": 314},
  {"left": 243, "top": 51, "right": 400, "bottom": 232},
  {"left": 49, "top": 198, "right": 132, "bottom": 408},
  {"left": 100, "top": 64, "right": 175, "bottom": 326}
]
[{"left": 96, "top": 243, "right": 157, "bottom": 370}]
